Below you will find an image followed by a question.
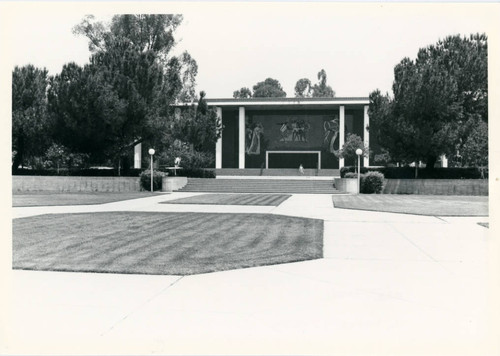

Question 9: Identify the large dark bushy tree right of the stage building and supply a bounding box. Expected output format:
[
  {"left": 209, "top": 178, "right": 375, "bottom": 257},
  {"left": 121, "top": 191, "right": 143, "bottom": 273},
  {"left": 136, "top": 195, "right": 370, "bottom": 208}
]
[{"left": 369, "top": 35, "right": 488, "bottom": 169}]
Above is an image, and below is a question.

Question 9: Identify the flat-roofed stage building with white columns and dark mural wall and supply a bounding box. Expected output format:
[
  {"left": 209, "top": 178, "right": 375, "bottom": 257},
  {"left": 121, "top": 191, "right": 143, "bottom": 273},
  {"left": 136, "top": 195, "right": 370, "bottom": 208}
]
[{"left": 135, "top": 97, "right": 370, "bottom": 169}]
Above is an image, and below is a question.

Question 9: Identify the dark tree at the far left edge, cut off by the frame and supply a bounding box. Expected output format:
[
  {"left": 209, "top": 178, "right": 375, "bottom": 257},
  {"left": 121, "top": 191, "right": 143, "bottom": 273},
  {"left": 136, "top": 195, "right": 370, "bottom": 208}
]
[{"left": 12, "top": 64, "right": 51, "bottom": 171}]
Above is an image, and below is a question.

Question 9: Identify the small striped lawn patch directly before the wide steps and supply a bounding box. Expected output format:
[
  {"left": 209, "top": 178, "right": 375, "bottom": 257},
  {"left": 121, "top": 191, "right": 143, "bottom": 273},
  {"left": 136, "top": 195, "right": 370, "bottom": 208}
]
[{"left": 162, "top": 194, "right": 291, "bottom": 206}]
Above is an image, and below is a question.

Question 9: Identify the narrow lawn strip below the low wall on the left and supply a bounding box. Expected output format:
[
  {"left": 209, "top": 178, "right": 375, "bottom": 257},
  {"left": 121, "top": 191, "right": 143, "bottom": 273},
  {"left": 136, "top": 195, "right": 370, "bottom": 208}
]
[{"left": 12, "top": 192, "right": 160, "bottom": 207}]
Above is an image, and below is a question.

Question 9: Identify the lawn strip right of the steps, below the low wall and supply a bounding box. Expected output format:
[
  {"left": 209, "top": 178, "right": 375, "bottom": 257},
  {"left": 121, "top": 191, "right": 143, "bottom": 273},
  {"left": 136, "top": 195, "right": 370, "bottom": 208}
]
[{"left": 332, "top": 194, "right": 488, "bottom": 216}]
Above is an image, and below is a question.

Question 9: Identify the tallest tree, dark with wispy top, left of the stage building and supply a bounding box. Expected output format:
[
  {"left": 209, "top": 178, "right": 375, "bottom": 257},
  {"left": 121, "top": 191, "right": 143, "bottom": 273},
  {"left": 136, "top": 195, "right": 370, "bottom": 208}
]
[{"left": 58, "top": 15, "right": 198, "bottom": 169}]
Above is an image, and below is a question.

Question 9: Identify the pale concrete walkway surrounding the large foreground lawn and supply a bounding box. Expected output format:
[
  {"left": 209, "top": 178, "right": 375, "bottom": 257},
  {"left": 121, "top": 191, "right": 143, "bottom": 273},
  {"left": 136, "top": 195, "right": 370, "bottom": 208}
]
[{"left": 1, "top": 193, "right": 500, "bottom": 355}]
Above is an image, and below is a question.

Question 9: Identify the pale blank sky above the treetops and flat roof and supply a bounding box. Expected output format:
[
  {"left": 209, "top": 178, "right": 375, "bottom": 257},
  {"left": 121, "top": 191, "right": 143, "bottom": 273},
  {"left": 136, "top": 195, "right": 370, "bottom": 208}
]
[{"left": 2, "top": 2, "right": 491, "bottom": 98}]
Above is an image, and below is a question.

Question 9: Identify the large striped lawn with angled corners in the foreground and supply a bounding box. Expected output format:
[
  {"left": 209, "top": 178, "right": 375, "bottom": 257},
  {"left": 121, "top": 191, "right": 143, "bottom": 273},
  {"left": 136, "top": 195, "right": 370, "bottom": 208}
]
[{"left": 12, "top": 212, "right": 323, "bottom": 275}]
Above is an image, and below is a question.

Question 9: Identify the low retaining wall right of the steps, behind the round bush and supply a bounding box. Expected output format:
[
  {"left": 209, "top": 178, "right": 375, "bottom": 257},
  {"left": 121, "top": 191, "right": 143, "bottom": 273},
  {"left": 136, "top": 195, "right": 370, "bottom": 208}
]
[{"left": 382, "top": 179, "right": 488, "bottom": 195}]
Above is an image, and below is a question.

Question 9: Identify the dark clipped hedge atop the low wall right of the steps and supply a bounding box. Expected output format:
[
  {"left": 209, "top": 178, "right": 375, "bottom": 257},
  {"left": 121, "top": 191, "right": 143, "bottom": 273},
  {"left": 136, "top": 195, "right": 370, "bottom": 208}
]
[{"left": 340, "top": 166, "right": 488, "bottom": 179}]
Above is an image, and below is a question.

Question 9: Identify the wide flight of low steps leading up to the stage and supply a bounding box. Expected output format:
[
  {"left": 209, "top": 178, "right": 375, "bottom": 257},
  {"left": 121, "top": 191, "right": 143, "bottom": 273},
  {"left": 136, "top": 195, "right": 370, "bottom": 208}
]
[{"left": 174, "top": 177, "right": 340, "bottom": 194}]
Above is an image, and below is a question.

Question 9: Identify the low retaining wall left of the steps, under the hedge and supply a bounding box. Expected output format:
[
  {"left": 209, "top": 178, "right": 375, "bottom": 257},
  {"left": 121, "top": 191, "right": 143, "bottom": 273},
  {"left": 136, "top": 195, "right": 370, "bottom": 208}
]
[{"left": 12, "top": 176, "right": 141, "bottom": 192}]
